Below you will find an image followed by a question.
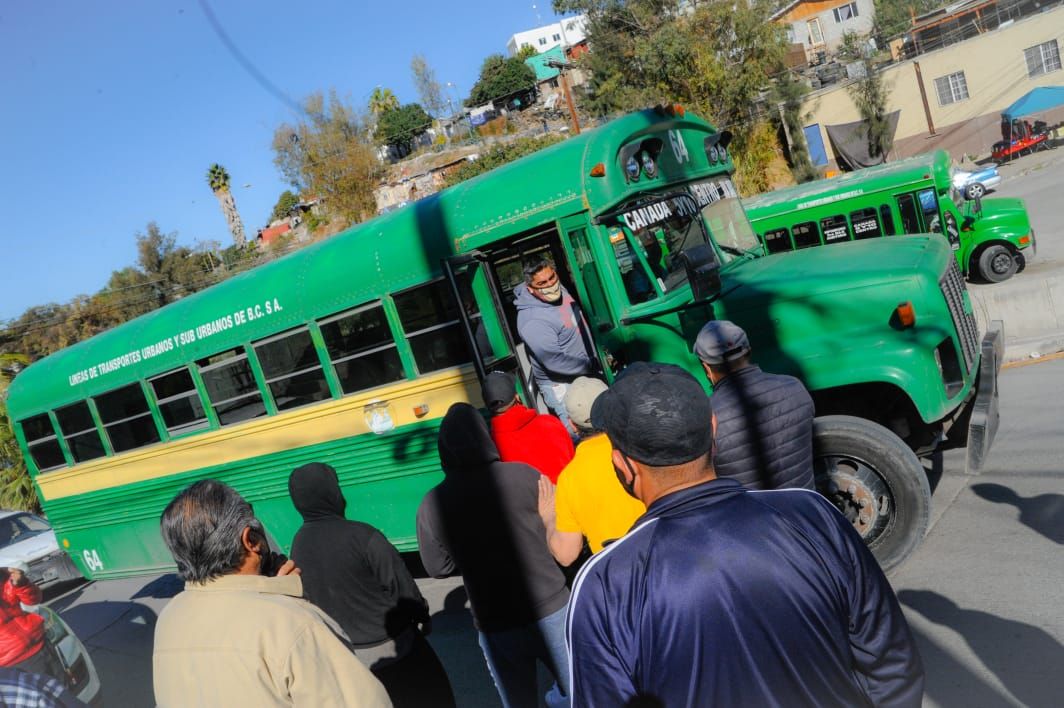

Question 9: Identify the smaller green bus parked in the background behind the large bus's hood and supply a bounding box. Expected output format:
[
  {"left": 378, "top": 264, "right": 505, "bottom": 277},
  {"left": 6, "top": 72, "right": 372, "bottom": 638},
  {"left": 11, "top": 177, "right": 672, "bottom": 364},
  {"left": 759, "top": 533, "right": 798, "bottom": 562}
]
[{"left": 744, "top": 150, "right": 1035, "bottom": 282}]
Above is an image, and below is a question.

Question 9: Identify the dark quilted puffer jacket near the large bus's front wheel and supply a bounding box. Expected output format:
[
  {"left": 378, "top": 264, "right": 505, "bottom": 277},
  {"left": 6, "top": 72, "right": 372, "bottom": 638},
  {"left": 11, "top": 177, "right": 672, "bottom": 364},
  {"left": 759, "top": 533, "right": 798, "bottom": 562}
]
[{"left": 712, "top": 365, "right": 814, "bottom": 490}]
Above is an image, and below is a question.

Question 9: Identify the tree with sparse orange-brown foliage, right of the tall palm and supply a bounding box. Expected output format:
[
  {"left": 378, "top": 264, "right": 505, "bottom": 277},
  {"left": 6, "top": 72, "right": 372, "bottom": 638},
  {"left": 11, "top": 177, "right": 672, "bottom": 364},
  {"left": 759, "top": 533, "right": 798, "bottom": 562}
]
[{"left": 273, "top": 92, "right": 382, "bottom": 224}]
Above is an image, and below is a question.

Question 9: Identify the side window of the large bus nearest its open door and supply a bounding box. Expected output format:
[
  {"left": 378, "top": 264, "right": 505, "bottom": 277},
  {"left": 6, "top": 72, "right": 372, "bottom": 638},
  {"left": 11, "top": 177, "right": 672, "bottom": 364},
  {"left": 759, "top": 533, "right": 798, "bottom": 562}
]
[{"left": 393, "top": 280, "right": 476, "bottom": 374}]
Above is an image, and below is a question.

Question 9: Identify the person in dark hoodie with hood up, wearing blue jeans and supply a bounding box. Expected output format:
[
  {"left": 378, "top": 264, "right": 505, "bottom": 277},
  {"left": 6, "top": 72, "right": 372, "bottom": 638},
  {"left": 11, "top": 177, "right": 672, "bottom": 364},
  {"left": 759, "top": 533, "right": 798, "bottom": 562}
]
[{"left": 414, "top": 404, "right": 569, "bottom": 708}]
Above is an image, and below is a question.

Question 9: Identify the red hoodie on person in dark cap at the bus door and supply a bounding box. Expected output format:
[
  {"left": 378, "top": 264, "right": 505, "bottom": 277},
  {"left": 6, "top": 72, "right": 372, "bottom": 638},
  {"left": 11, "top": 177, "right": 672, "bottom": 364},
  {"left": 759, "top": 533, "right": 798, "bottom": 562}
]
[{"left": 492, "top": 404, "right": 573, "bottom": 483}]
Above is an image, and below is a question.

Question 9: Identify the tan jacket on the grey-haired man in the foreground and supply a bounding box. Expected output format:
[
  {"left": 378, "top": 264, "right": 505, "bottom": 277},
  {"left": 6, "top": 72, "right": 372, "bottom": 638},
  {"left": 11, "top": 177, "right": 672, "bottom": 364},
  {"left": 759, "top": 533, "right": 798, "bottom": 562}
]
[{"left": 152, "top": 575, "right": 392, "bottom": 708}]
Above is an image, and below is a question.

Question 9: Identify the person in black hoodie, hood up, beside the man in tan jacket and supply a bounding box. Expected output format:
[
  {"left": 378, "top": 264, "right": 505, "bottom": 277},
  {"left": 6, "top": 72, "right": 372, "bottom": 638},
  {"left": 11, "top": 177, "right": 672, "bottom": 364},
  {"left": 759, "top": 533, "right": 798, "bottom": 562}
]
[{"left": 288, "top": 462, "right": 454, "bottom": 708}]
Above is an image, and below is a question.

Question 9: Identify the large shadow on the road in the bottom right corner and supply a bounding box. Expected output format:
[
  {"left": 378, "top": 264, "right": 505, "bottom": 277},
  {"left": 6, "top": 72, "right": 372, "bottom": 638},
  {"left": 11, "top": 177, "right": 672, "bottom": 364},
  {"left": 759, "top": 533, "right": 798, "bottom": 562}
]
[{"left": 898, "top": 590, "right": 1064, "bottom": 707}]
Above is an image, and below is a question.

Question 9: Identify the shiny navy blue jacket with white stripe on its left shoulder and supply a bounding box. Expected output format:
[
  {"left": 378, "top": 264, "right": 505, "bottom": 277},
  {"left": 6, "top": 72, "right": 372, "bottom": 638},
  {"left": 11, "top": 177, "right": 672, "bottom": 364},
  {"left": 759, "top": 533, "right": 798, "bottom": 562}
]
[{"left": 566, "top": 479, "right": 924, "bottom": 708}]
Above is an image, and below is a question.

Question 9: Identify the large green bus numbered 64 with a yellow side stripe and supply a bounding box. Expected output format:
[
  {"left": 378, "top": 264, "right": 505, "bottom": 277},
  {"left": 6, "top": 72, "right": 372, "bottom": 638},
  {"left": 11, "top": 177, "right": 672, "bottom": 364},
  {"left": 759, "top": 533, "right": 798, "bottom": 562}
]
[{"left": 9, "top": 106, "right": 1000, "bottom": 578}]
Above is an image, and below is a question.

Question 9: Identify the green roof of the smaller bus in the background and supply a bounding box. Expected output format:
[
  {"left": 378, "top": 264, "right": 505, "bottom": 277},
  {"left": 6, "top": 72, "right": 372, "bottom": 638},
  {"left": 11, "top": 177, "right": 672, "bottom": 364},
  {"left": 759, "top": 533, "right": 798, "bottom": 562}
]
[{"left": 743, "top": 150, "right": 950, "bottom": 219}]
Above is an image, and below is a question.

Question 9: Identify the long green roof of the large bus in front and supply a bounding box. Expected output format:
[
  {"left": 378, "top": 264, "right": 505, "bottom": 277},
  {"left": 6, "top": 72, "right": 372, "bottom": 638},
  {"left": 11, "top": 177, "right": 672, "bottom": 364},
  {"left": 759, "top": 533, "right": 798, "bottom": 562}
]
[{"left": 9, "top": 110, "right": 715, "bottom": 421}]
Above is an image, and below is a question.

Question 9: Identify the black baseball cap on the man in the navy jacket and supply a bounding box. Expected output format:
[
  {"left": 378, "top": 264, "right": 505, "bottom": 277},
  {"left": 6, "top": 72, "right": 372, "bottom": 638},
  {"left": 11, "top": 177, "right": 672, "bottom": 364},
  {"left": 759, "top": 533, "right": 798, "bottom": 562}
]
[{"left": 592, "top": 362, "right": 713, "bottom": 467}]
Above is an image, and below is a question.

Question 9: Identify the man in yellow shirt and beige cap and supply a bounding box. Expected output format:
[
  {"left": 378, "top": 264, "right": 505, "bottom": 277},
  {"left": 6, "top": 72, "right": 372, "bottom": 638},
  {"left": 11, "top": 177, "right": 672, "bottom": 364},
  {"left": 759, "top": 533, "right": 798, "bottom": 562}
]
[{"left": 539, "top": 377, "right": 646, "bottom": 565}]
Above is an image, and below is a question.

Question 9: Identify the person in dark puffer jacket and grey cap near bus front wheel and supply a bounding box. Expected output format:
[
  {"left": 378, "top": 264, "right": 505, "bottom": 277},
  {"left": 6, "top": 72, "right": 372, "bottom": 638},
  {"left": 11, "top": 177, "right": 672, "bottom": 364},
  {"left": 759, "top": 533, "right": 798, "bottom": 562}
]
[{"left": 695, "top": 319, "right": 815, "bottom": 490}]
